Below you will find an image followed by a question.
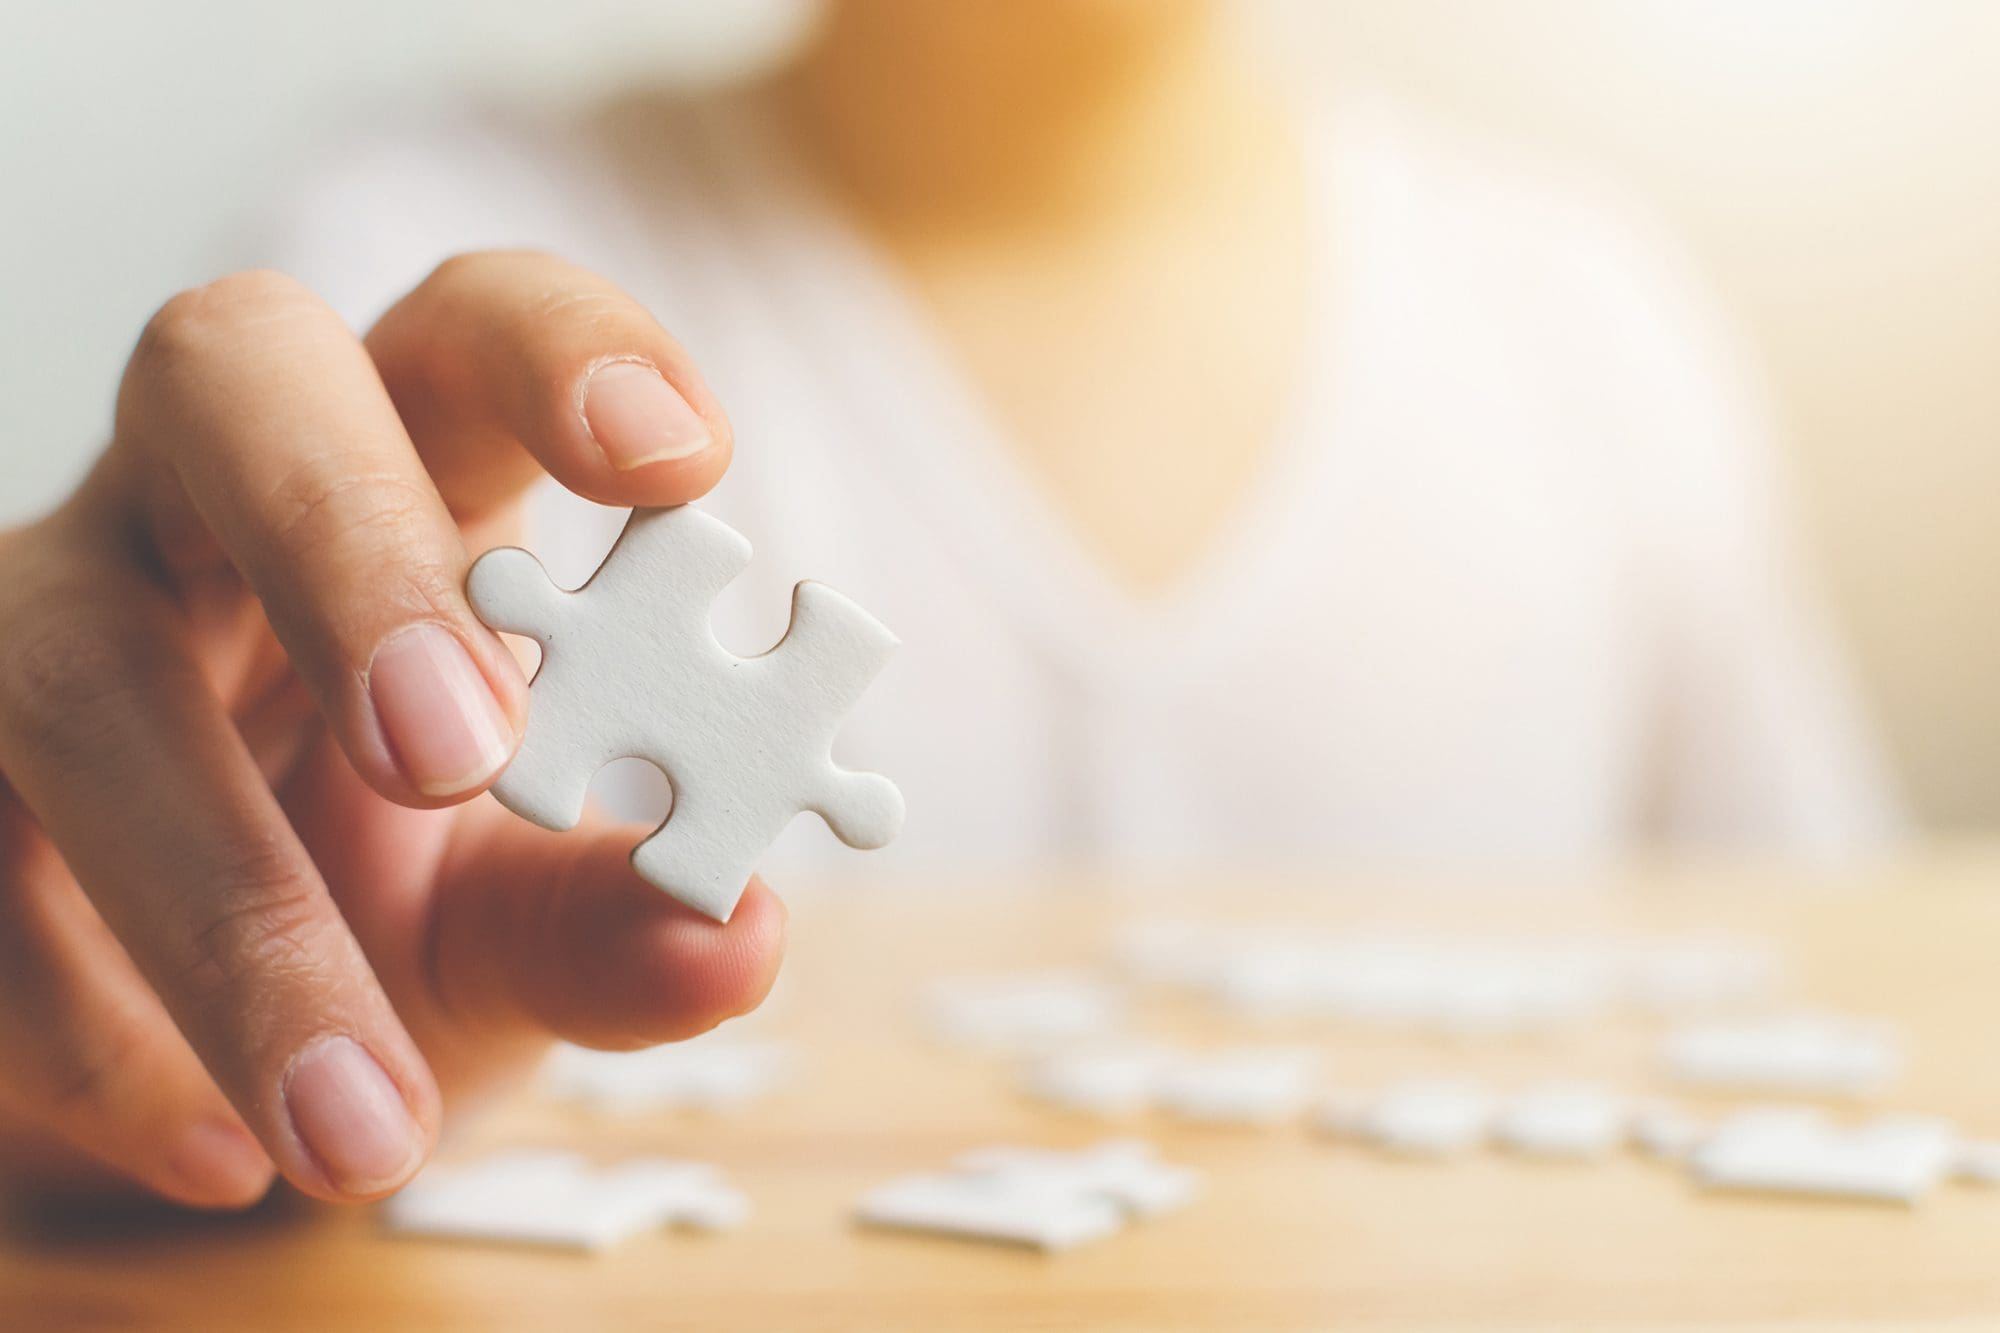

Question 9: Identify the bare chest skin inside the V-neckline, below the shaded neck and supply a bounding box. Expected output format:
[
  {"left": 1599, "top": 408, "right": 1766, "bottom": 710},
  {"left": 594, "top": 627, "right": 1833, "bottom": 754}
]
[{"left": 876, "top": 162, "right": 1316, "bottom": 594}]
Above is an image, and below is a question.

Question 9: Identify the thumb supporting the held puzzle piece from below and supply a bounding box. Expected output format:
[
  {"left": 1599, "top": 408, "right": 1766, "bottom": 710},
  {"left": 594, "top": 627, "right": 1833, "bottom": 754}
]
[{"left": 432, "top": 819, "right": 786, "bottom": 1049}]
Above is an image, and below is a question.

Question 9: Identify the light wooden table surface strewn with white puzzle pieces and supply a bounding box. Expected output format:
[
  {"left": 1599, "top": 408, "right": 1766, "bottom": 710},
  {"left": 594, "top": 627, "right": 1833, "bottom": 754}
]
[{"left": 0, "top": 851, "right": 2000, "bottom": 1333}]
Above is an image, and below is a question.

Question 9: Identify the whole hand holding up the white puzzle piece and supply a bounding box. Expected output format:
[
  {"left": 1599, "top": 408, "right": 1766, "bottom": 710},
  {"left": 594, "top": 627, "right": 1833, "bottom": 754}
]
[{"left": 0, "top": 254, "right": 784, "bottom": 1207}]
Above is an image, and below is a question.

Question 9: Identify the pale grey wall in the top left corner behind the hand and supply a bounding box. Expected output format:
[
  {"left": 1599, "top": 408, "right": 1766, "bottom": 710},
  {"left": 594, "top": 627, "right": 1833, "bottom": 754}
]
[{"left": 0, "top": 0, "right": 810, "bottom": 524}]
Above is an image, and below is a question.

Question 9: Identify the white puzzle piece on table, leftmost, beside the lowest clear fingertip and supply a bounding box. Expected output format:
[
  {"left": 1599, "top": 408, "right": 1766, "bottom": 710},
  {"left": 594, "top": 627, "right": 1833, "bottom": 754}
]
[{"left": 382, "top": 1153, "right": 748, "bottom": 1251}]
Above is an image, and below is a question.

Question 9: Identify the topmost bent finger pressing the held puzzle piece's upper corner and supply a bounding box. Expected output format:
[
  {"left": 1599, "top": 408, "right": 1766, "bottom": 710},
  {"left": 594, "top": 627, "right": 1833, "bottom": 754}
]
[{"left": 368, "top": 250, "right": 732, "bottom": 514}]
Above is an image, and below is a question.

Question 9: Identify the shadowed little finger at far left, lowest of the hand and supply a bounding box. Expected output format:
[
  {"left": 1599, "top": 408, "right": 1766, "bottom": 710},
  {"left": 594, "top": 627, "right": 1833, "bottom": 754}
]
[{"left": 0, "top": 809, "right": 272, "bottom": 1207}]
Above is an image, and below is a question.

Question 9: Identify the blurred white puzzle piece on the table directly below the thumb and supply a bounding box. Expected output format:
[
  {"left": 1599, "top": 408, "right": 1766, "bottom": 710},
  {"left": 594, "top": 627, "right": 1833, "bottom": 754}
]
[{"left": 542, "top": 1035, "right": 794, "bottom": 1115}]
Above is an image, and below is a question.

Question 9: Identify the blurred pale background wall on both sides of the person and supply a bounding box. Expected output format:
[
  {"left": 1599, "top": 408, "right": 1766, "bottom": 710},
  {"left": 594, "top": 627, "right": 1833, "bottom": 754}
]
[{"left": 0, "top": 0, "right": 2000, "bottom": 831}]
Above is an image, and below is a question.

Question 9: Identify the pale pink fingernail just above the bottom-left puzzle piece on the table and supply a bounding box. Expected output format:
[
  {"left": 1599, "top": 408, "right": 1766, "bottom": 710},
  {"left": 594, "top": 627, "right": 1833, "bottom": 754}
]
[{"left": 284, "top": 1037, "right": 424, "bottom": 1195}]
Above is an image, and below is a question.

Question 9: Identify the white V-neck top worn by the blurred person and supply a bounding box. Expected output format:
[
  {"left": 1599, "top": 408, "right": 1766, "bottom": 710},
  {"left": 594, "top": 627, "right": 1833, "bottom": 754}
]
[{"left": 258, "top": 93, "right": 1896, "bottom": 873}]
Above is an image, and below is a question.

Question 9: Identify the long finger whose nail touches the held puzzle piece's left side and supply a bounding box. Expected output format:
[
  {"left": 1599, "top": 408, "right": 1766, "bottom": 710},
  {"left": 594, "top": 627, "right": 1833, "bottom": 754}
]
[{"left": 118, "top": 274, "right": 526, "bottom": 805}]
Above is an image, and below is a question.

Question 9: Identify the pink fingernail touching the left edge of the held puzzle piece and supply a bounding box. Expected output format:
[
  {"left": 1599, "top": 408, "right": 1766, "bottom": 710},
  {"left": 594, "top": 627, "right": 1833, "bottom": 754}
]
[{"left": 368, "top": 622, "right": 514, "bottom": 797}]
